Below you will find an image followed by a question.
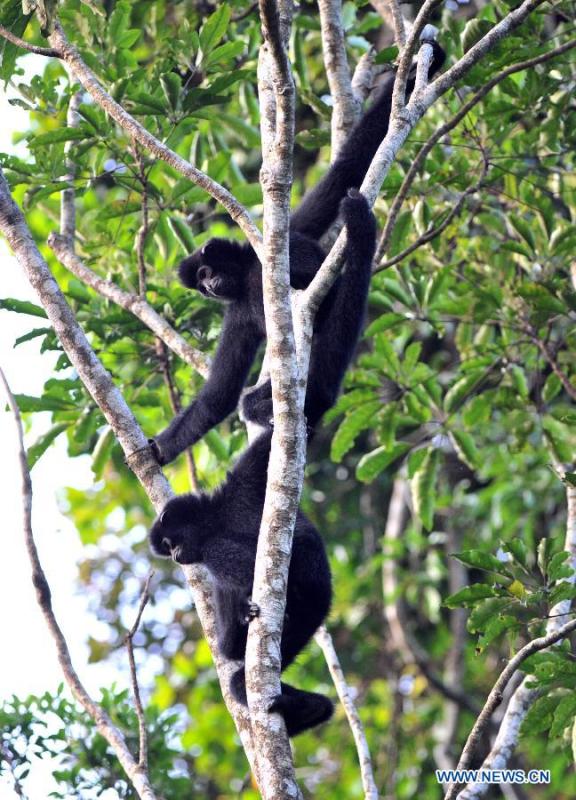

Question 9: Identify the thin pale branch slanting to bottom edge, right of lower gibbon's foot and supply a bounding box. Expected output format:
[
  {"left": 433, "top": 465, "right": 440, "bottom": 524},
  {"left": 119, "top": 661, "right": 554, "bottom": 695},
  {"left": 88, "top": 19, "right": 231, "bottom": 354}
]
[{"left": 314, "top": 625, "right": 379, "bottom": 800}]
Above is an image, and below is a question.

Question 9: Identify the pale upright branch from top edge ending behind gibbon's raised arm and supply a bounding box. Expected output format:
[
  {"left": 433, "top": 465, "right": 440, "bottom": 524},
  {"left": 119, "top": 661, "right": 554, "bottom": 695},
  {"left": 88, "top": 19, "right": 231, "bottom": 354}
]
[{"left": 318, "top": 0, "right": 360, "bottom": 161}]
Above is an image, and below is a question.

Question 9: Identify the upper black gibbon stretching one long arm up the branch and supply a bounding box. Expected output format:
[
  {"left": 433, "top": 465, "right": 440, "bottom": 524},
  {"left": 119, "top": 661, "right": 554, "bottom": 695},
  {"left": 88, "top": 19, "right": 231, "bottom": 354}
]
[{"left": 151, "top": 42, "right": 444, "bottom": 464}]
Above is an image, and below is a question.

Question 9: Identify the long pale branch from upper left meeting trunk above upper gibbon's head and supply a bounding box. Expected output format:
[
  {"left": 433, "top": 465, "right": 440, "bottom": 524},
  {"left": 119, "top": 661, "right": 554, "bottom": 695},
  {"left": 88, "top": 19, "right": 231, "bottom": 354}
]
[{"left": 49, "top": 22, "right": 262, "bottom": 254}]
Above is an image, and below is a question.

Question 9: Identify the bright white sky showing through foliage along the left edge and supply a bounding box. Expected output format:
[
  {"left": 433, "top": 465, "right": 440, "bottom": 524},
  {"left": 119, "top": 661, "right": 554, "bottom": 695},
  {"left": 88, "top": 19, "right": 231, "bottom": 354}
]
[{"left": 0, "top": 56, "right": 126, "bottom": 800}]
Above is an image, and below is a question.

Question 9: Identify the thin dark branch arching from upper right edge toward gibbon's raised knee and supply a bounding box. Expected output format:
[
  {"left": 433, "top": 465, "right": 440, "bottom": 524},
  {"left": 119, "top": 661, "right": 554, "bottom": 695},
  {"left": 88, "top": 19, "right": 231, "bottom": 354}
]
[{"left": 375, "top": 40, "right": 576, "bottom": 256}]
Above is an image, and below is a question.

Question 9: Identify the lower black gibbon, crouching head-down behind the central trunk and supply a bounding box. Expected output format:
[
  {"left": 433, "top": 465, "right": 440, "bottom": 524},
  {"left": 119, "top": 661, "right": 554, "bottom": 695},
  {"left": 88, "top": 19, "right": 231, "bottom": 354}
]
[{"left": 150, "top": 431, "right": 333, "bottom": 736}]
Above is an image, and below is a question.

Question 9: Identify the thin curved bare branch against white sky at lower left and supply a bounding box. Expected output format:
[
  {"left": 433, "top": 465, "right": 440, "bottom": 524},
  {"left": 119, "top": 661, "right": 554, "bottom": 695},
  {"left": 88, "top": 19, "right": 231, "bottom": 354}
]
[{"left": 0, "top": 369, "right": 158, "bottom": 800}]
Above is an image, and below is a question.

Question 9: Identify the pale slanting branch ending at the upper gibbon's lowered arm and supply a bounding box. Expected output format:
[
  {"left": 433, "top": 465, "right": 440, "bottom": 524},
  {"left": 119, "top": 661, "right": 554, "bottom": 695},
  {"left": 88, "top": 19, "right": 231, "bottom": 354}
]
[{"left": 48, "top": 233, "right": 210, "bottom": 378}]
